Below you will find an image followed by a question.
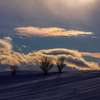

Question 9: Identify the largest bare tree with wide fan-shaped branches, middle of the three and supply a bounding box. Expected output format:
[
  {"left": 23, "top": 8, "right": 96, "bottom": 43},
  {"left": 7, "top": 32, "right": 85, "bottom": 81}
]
[{"left": 40, "top": 56, "right": 53, "bottom": 75}]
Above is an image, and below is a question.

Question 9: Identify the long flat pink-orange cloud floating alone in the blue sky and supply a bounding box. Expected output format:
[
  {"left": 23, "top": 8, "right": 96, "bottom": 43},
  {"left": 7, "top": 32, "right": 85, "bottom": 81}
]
[{"left": 15, "top": 26, "right": 93, "bottom": 36}]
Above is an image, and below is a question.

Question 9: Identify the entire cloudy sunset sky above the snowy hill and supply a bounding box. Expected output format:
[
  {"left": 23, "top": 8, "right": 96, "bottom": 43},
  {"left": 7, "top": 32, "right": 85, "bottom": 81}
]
[{"left": 0, "top": 0, "right": 100, "bottom": 70}]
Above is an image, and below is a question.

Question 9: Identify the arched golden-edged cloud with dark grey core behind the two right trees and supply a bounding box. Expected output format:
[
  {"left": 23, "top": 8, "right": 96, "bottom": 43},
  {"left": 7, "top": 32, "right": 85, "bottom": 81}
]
[{"left": 38, "top": 48, "right": 99, "bottom": 70}]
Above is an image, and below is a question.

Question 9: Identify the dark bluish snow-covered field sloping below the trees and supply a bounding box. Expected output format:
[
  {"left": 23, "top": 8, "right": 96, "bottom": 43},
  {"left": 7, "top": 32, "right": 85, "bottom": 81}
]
[{"left": 0, "top": 71, "right": 100, "bottom": 100}]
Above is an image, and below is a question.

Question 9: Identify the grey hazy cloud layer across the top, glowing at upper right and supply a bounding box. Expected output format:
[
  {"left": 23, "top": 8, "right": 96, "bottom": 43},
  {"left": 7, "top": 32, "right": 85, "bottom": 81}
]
[{"left": 0, "top": 0, "right": 100, "bottom": 36}]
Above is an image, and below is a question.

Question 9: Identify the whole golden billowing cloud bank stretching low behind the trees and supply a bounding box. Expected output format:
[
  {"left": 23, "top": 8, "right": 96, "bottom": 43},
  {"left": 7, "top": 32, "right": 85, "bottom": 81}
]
[{"left": 0, "top": 40, "right": 100, "bottom": 70}]
